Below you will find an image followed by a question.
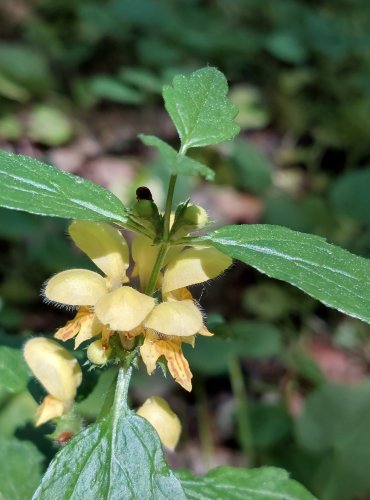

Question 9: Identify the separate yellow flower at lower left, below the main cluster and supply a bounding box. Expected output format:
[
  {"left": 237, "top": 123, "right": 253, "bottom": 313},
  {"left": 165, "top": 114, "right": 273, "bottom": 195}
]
[{"left": 23, "top": 337, "right": 82, "bottom": 426}]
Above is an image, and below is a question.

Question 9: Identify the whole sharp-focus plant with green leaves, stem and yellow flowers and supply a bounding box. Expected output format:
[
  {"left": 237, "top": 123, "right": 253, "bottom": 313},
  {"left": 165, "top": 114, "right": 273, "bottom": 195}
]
[{"left": 0, "top": 67, "right": 370, "bottom": 500}]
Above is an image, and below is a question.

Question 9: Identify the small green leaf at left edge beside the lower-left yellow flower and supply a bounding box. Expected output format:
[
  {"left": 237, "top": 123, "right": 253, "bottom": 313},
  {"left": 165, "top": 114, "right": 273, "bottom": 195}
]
[{"left": 0, "top": 346, "right": 30, "bottom": 393}]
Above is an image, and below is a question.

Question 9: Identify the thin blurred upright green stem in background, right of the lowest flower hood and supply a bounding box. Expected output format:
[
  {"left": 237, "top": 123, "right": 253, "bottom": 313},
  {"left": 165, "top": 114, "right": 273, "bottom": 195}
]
[{"left": 229, "top": 357, "right": 255, "bottom": 467}]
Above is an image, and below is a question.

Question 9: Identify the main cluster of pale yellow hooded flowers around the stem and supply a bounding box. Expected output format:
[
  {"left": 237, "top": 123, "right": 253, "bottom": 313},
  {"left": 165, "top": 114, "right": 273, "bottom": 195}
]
[{"left": 44, "top": 217, "right": 232, "bottom": 400}]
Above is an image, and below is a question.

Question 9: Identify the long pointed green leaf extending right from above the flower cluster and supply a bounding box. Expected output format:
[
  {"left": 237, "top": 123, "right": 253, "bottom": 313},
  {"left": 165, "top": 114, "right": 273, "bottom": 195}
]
[{"left": 204, "top": 224, "right": 370, "bottom": 323}]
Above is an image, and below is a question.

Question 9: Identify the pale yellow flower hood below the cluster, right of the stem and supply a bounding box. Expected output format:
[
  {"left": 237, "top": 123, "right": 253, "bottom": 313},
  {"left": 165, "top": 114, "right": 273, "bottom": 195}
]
[{"left": 136, "top": 396, "right": 181, "bottom": 450}]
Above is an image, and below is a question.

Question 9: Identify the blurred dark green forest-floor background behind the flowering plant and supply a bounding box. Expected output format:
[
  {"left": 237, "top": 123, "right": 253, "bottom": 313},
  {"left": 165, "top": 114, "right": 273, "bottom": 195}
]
[{"left": 0, "top": 0, "right": 370, "bottom": 500}]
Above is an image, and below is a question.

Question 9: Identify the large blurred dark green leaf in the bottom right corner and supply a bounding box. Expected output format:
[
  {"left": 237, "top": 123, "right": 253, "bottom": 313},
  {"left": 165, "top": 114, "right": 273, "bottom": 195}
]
[{"left": 295, "top": 381, "right": 370, "bottom": 500}]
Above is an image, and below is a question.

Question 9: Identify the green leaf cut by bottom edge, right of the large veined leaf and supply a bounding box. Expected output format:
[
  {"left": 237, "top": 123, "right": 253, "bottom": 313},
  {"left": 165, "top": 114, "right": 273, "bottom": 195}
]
[{"left": 176, "top": 467, "right": 315, "bottom": 500}]
